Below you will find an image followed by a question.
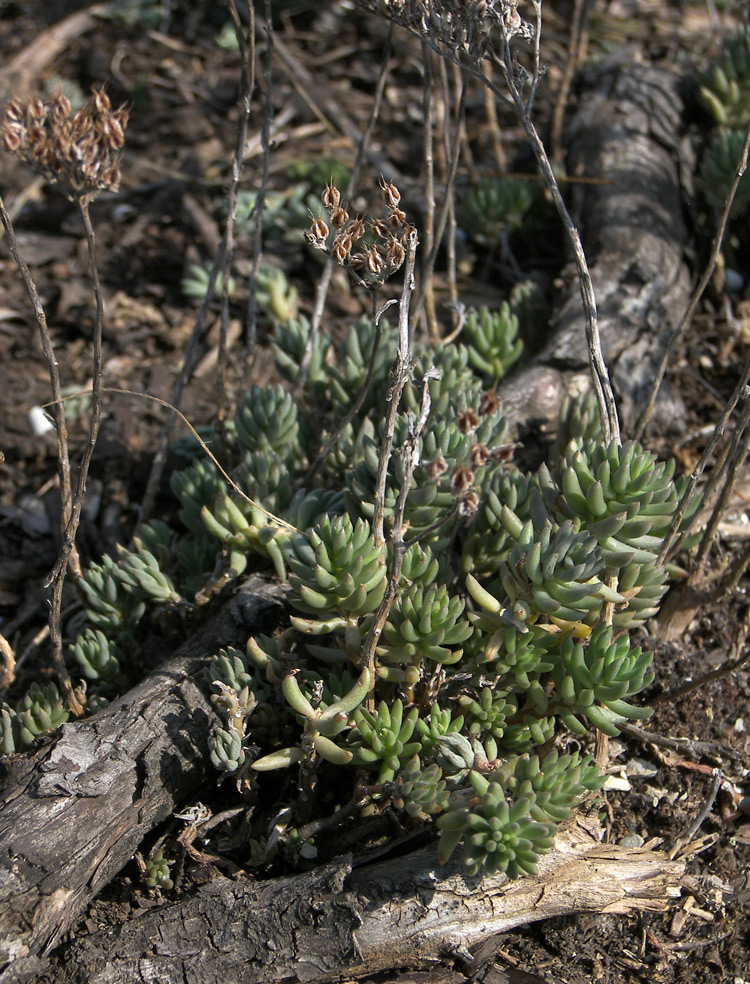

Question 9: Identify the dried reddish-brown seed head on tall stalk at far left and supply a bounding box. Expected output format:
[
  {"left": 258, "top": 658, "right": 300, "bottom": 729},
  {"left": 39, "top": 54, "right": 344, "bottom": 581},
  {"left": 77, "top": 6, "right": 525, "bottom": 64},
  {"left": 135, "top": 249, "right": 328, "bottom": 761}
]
[{"left": 0, "top": 89, "right": 128, "bottom": 201}]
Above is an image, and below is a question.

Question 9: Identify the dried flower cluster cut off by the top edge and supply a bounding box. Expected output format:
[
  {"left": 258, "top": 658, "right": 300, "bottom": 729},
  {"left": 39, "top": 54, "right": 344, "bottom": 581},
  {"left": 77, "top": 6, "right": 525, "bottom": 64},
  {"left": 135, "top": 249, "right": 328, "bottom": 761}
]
[{"left": 359, "top": 0, "right": 534, "bottom": 61}]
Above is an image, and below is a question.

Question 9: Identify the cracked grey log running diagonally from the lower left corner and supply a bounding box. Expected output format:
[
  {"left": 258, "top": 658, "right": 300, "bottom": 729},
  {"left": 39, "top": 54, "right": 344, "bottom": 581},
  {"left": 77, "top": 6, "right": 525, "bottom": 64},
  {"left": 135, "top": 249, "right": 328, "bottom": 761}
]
[{"left": 0, "top": 578, "right": 288, "bottom": 982}]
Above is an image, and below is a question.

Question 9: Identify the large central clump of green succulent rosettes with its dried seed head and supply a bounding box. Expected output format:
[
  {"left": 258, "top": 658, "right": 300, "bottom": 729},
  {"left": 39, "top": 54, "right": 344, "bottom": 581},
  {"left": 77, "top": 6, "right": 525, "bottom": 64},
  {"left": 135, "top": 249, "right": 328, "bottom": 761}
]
[{"left": 2, "top": 182, "right": 696, "bottom": 878}]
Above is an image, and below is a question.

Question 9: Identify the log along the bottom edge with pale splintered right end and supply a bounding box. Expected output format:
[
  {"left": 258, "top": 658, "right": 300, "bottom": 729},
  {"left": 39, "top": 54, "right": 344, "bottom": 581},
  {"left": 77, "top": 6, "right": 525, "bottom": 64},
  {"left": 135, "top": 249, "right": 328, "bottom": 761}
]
[{"left": 44, "top": 821, "right": 684, "bottom": 984}]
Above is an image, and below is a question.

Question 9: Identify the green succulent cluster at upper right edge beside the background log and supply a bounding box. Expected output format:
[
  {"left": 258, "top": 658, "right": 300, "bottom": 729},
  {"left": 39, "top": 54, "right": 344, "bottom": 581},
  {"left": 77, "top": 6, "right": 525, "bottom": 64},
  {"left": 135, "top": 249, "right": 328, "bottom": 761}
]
[{"left": 698, "top": 27, "right": 750, "bottom": 216}]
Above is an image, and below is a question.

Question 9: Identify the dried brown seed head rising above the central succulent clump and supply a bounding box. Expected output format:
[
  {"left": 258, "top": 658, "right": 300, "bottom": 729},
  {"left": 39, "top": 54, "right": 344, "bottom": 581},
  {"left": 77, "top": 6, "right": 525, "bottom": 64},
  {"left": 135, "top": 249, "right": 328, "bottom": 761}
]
[{"left": 305, "top": 177, "right": 411, "bottom": 290}]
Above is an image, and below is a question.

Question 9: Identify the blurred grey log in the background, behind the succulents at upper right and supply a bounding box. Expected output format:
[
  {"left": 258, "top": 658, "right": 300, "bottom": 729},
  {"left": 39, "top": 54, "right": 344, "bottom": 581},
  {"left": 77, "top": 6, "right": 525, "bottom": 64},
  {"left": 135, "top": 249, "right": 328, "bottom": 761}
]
[{"left": 498, "top": 56, "right": 690, "bottom": 436}]
